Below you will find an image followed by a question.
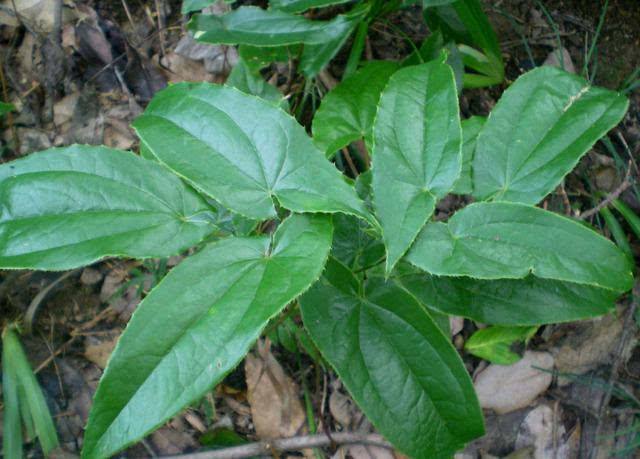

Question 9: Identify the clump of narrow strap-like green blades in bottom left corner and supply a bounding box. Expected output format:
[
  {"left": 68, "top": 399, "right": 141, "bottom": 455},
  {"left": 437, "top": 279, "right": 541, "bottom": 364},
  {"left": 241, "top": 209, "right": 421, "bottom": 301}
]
[{"left": 2, "top": 325, "right": 58, "bottom": 459}]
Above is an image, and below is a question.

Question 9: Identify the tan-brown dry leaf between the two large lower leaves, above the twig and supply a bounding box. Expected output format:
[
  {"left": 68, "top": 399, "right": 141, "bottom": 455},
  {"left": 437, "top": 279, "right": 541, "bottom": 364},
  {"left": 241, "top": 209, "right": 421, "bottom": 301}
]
[{"left": 245, "top": 349, "right": 306, "bottom": 439}]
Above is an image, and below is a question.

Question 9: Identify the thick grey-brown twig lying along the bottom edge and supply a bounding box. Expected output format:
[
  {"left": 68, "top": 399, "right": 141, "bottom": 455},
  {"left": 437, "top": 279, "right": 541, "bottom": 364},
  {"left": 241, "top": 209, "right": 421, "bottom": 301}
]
[{"left": 165, "top": 432, "right": 392, "bottom": 459}]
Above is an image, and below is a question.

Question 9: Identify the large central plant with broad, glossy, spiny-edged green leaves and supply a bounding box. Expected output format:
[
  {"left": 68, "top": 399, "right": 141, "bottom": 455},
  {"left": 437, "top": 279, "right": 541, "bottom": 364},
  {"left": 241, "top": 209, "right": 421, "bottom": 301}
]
[{"left": 0, "top": 56, "right": 632, "bottom": 458}]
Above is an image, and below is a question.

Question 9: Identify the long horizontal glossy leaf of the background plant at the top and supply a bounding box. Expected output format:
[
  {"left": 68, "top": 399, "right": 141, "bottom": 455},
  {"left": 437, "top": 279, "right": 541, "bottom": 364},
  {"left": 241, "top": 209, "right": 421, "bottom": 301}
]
[{"left": 189, "top": 6, "right": 360, "bottom": 46}]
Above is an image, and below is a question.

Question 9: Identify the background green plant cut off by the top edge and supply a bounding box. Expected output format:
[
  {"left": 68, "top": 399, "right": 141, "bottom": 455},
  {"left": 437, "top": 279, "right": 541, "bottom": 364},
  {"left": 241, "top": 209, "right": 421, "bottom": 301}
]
[{"left": 182, "top": 0, "right": 504, "bottom": 88}]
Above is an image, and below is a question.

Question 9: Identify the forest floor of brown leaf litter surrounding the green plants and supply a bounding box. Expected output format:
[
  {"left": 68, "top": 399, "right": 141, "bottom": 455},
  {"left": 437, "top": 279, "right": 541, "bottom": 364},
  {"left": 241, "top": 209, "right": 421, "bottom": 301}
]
[{"left": 0, "top": 0, "right": 640, "bottom": 459}]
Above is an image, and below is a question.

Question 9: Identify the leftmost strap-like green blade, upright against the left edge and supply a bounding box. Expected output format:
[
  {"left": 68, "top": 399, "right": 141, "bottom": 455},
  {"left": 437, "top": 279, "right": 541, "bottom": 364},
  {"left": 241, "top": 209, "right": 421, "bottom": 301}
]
[{"left": 2, "top": 327, "right": 23, "bottom": 459}]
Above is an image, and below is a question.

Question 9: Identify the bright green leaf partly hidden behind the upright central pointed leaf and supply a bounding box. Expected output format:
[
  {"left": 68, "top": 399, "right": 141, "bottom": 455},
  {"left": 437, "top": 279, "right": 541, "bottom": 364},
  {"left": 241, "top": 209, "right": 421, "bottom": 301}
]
[{"left": 313, "top": 61, "right": 398, "bottom": 157}]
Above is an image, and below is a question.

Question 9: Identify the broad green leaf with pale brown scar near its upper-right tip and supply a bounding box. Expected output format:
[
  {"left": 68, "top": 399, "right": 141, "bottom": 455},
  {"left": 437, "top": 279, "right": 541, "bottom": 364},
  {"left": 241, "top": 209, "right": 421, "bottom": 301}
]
[{"left": 473, "top": 66, "right": 628, "bottom": 204}]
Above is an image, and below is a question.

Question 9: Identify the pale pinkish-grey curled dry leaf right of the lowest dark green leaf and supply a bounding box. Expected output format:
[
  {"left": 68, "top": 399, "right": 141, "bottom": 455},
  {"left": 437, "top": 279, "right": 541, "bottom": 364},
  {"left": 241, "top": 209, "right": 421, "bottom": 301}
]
[{"left": 474, "top": 351, "right": 553, "bottom": 414}]
